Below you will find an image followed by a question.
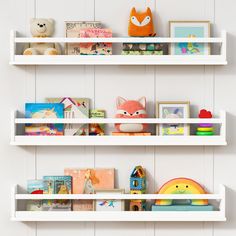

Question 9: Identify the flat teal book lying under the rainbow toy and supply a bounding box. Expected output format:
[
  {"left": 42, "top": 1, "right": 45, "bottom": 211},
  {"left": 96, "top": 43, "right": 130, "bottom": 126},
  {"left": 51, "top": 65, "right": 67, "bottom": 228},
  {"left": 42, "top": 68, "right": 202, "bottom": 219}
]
[{"left": 152, "top": 205, "right": 214, "bottom": 211}]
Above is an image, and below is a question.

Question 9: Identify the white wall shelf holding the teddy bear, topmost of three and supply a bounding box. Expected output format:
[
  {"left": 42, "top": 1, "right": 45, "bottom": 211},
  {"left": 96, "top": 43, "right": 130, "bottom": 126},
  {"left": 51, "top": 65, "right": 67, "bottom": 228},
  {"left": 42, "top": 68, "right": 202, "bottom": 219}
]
[{"left": 10, "top": 30, "right": 227, "bottom": 65}]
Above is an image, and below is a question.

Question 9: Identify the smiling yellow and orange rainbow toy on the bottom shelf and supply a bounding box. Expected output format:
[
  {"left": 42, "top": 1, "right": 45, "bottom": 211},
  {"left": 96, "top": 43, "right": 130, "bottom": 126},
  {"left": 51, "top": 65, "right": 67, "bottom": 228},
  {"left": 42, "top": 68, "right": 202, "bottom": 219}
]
[{"left": 155, "top": 178, "right": 208, "bottom": 206}]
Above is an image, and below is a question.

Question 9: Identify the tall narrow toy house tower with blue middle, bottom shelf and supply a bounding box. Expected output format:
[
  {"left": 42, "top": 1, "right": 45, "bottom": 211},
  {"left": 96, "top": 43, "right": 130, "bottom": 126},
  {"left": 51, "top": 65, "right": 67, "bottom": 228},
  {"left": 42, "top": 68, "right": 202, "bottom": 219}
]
[{"left": 129, "top": 166, "right": 147, "bottom": 211}]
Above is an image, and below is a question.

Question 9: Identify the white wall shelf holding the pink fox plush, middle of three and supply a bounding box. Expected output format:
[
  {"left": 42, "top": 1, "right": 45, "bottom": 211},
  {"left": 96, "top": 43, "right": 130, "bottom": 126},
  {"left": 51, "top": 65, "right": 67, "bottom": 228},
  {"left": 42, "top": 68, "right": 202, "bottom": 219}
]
[{"left": 11, "top": 111, "right": 227, "bottom": 146}]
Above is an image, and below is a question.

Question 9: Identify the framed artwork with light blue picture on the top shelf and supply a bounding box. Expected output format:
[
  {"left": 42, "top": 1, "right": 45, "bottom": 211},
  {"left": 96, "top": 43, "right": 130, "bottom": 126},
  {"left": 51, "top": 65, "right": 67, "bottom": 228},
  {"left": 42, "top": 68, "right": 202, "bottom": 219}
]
[{"left": 169, "top": 21, "right": 210, "bottom": 55}]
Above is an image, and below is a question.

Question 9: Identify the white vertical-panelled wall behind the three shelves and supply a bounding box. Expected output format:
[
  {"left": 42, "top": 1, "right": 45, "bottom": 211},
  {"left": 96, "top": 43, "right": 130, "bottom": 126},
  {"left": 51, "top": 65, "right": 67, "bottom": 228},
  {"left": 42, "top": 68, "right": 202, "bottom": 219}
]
[{"left": 0, "top": 0, "right": 236, "bottom": 236}]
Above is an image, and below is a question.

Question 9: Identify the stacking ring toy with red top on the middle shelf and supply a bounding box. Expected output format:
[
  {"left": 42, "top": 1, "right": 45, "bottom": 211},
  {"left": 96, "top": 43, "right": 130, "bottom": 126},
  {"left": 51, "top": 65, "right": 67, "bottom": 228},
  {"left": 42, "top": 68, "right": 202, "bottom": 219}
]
[{"left": 196, "top": 109, "right": 214, "bottom": 136}]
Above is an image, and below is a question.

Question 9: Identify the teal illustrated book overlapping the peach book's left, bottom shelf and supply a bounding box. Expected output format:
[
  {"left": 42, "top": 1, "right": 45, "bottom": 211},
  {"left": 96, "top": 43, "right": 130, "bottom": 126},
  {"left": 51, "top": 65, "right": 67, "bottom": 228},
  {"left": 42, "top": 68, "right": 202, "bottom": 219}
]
[{"left": 43, "top": 176, "right": 72, "bottom": 211}]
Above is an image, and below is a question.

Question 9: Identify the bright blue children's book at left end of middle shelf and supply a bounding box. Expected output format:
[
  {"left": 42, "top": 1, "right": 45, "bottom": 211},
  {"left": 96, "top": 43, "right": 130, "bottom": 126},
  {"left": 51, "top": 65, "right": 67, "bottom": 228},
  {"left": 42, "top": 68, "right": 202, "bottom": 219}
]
[{"left": 25, "top": 103, "right": 64, "bottom": 136}]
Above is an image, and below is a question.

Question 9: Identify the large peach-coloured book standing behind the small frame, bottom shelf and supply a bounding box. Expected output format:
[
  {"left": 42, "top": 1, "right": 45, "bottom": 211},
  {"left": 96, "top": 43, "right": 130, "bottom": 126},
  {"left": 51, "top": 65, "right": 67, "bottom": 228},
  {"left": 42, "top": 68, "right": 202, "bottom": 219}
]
[{"left": 64, "top": 168, "right": 115, "bottom": 211}]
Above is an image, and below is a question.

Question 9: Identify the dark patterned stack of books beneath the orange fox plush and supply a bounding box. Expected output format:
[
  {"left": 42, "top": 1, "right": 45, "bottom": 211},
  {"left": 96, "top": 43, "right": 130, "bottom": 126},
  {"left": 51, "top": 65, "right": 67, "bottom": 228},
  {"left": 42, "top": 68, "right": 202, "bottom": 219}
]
[{"left": 122, "top": 43, "right": 168, "bottom": 55}]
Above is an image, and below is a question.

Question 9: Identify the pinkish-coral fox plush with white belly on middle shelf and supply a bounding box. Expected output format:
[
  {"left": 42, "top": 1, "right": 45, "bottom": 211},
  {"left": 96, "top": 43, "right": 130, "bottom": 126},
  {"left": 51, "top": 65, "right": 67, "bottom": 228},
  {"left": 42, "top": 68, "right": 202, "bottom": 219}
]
[{"left": 115, "top": 97, "right": 147, "bottom": 133}]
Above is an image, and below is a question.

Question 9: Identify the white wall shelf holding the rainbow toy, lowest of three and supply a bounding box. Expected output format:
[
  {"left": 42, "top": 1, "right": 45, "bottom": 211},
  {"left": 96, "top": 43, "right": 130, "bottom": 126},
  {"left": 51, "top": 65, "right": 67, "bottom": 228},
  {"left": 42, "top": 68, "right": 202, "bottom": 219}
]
[{"left": 11, "top": 185, "right": 226, "bottom": 222}]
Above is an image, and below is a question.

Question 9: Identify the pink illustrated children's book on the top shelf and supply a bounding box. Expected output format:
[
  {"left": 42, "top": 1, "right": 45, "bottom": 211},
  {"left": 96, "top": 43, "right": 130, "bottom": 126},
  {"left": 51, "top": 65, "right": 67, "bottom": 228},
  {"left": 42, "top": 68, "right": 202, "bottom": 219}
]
[{"left": 80, "top": 28, "right": 112, "bottom": 55}]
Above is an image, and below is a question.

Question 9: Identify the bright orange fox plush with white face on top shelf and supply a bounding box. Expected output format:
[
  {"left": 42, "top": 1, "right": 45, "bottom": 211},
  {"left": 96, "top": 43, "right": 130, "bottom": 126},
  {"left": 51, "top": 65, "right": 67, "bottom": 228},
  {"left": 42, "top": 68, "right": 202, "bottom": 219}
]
[{"left": 128, "top": 7, "right": 155, "bottom": 37}]
